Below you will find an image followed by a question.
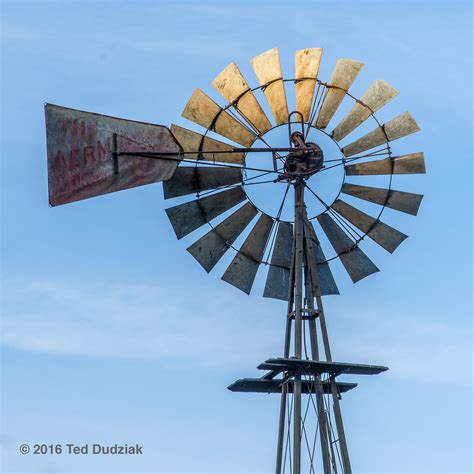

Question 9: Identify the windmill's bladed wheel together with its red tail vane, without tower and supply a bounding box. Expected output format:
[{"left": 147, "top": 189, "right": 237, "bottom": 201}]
[{"left": 46, "top": 48, "right": 425, "bottom": 300}]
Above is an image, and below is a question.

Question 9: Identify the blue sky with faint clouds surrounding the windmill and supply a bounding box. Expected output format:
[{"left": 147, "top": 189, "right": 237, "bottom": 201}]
[{"left": 1, "top": 1, "right": 472, "bottom": 473}]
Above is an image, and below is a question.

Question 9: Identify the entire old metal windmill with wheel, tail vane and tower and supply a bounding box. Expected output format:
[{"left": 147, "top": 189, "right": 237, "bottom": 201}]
[{"left": 45, "top": 48, "right": 425, "bottom": 474}]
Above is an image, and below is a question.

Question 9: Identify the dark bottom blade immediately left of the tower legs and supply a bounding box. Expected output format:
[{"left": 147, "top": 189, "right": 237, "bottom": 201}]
[{"left": 263, "top": 222, "right": 293, "bottom": 301}]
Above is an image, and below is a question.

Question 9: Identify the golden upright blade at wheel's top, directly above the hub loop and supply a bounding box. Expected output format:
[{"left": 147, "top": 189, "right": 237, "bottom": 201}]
[{"left": 295, "top": 48, "right": 323, "bottom": 122}]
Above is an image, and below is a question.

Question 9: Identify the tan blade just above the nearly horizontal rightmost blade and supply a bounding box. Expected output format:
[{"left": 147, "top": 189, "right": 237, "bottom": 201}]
[{"left": 342, "top": 112, "right": 420, "bottom": 156}]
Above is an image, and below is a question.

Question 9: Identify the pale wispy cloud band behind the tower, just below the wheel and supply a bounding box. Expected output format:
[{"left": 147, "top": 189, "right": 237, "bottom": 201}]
[{"left": 3, "top": 281, "right": 471, "bottom": 383}]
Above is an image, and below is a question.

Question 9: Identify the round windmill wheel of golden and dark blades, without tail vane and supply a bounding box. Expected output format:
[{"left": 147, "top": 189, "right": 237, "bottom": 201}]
[{"left": 163, "top": 48, "right": 425, "bottom": 300}]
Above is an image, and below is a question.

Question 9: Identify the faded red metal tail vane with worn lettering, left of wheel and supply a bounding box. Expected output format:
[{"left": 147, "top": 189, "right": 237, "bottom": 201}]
[{"left": 45, "top": 104, "right": 180, "bottom": 206}]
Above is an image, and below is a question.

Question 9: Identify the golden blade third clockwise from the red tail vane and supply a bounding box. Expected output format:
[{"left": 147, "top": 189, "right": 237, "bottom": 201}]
[{"left": 212, "top": 63, "right": 272, "bottom": 134}]
